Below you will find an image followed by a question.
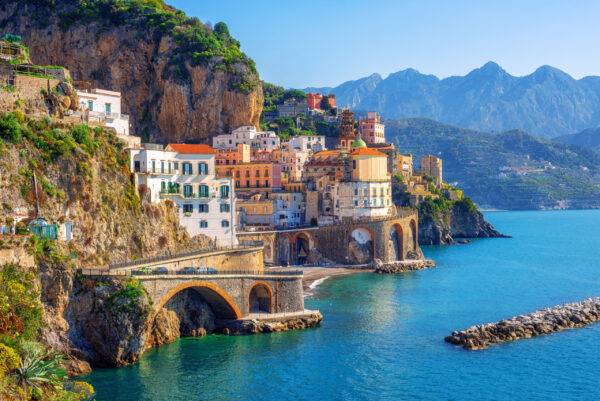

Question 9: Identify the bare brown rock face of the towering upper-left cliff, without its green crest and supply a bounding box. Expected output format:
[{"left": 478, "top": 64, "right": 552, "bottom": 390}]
[{"left": 0, "top": 0, "right": 263, "bottom": 142}]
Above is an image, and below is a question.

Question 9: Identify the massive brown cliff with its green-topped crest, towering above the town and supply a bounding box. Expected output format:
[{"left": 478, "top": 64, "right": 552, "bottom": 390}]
[{"left": 0, "top": 0, "right": 263, "bottom": 142}]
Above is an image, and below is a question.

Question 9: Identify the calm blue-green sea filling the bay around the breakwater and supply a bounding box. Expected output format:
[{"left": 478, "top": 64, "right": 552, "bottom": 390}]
[{"left": 87, "top": 211, "right": 600, "bottom": 401}]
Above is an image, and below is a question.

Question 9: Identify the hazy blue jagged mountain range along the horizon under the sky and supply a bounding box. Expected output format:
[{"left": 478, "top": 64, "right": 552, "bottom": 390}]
[{"left": 304, "top": 62, "right": 600, "bottom": 138}]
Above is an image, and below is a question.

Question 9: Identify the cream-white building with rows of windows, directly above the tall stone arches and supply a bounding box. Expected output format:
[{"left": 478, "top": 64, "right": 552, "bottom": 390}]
[{"left": 332, "top": 181, "right": 392, "bottom": 219}]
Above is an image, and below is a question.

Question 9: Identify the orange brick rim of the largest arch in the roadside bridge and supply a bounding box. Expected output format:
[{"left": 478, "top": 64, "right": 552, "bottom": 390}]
[{"left": 154, "top": 280, "right": 242, "bottom": 319}]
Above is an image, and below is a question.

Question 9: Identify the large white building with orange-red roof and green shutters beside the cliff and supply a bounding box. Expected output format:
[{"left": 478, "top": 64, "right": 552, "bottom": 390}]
[{"left": 131, "top": 144, "right": 237, "bottom": 245}]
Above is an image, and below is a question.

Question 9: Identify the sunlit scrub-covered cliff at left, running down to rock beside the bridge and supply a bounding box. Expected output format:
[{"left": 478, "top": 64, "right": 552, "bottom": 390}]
[{"left": 0, "top": 110, "right": 209, "bottom": 373}]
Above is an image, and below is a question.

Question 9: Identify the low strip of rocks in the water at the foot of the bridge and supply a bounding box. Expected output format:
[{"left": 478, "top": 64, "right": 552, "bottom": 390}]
[{"left": 221, "top": 311, "right": 323, "bottom": 335}]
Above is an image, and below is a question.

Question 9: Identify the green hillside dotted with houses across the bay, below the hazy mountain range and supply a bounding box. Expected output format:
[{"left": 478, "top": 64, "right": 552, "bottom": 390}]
[{"left": 386, "top": 119, "right": 600, "bottom": 210}]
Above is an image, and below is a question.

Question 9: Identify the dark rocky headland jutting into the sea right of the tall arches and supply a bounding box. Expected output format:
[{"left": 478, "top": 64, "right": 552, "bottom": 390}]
[{"left": 419, "top": 203, "right": 505, "bottom": 245}]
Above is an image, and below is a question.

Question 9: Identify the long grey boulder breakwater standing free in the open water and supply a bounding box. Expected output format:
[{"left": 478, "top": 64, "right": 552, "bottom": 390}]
[{"left": 444, "top": 298, "right": 600, "bottom": 350}]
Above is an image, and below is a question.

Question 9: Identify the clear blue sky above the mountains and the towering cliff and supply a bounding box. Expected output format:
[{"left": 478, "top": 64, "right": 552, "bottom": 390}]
[{"left": 166, "top": 0, "right": 600, "bottom": 87}]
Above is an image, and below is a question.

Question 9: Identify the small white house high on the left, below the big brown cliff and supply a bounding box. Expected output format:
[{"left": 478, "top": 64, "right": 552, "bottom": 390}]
[{"left": 77, "top": 89, "right": 129, "bottom": 136}]
